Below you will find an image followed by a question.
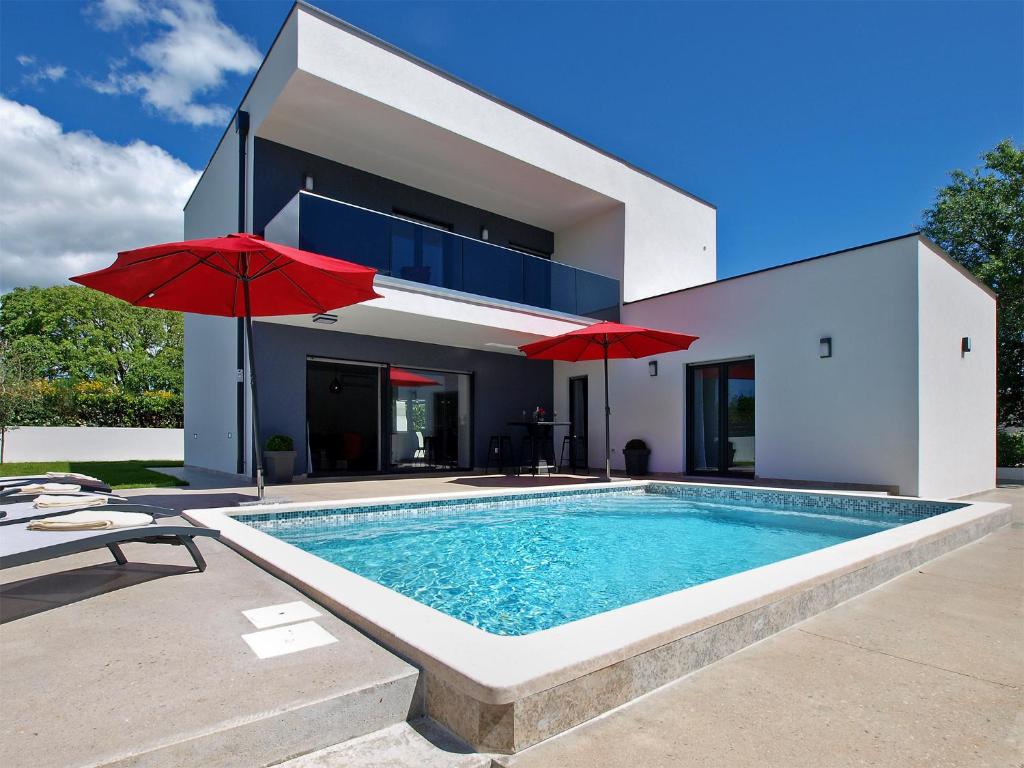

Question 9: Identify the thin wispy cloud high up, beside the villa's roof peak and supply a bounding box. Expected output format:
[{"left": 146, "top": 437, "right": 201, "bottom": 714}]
[{"left": 86, "top": 0, "right": 262, "bottom": 125}]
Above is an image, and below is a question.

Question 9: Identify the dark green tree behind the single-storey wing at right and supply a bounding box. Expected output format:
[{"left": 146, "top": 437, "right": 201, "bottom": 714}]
[{"left": 922, "top": 139, "right": 1024, "bottom": 427}]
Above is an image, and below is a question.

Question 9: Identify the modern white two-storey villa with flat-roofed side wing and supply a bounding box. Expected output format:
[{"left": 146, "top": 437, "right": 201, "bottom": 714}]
[{"left": 184, "top": 3, "right": 995, "bottom": 505}]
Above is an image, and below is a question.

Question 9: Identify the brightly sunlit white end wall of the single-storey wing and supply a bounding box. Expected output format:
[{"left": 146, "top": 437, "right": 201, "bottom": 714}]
[{"left": 918, "top": 242, "right": 996, "bottom": 497}]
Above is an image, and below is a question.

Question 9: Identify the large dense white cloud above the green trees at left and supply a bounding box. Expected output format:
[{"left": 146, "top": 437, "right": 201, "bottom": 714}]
[{"left": 0, "top": 96, "right": 199, "bottom": 292}]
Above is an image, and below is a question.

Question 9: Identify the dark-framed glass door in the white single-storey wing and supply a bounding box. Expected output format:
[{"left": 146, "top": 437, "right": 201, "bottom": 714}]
[{"left": 686, "top": 359, "right": 755, "bottom": 476}]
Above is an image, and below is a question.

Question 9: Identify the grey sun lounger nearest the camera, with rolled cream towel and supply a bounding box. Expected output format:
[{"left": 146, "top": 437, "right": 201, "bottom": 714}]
[{"left": 0, "top": 512, "right": 220, "bottom": 571}]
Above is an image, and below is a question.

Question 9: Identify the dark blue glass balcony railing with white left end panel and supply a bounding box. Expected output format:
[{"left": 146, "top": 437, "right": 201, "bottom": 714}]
[{"left": 266, "top": 191, "right": 620, "bottom": 321}]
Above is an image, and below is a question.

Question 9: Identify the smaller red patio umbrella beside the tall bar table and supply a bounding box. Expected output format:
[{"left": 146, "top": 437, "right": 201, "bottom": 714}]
[{"left": 519, "top": 322, "right": 699, "bottom": 480}]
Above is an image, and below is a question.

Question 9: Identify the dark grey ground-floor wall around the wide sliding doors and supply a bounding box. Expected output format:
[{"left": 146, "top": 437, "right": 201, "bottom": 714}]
[{"left": 253, "top": 315, "right": 561, "bottom": 473}]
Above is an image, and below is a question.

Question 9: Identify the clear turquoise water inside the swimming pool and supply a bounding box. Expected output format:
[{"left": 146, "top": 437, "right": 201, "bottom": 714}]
[{"left": 250, "top": 493, "right": 910, "bottom": 635}]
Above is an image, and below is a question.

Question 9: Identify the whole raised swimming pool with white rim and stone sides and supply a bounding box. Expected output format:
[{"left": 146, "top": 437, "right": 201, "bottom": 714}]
[{"left": 197, "top": 480, "right": 1011, "bottom": 753}]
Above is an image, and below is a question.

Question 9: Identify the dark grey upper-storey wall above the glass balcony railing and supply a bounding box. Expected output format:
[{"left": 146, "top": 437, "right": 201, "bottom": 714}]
[{"left": 253, "top": 138, "right": 555, "bottom": 255}]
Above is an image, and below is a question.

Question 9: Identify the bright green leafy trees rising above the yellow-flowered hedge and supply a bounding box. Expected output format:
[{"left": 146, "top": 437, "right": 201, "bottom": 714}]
[{"left": 0, "top": 286, "right": 184, "bottom": 393}]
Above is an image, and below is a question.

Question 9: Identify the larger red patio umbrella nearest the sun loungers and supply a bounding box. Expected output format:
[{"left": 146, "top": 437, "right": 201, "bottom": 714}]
[{"left": 72, "top": 233, "right": 380, "bottom": 499}]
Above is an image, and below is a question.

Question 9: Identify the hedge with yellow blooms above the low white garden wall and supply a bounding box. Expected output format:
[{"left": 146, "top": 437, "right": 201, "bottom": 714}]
[{"left": 2, "top": 381, "right": 184, "bottom": 428}]
